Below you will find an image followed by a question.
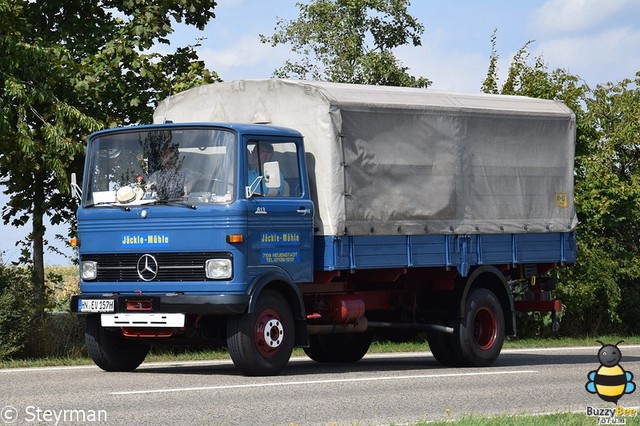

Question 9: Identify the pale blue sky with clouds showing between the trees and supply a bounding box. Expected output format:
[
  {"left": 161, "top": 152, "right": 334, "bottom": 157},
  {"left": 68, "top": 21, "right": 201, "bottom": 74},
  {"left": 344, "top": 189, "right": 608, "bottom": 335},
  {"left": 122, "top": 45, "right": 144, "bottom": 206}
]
[{"left": 0, "top": 0, "right": 640, "bottom": 265}]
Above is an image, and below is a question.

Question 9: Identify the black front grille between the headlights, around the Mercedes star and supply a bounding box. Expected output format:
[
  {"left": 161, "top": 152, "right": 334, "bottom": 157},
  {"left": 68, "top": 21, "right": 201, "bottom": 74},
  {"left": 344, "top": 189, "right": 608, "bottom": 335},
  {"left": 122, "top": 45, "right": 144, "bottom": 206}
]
[{"left": 81, "top": 252, "right": 231, "bottom": 282}]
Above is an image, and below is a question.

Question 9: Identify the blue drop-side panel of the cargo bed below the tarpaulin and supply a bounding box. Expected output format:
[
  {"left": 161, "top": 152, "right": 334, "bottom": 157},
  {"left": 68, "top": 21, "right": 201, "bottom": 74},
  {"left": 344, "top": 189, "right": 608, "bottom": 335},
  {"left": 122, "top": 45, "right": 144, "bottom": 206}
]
[{"left": 315, "top": 232, "right": 576, "bottom": 275}]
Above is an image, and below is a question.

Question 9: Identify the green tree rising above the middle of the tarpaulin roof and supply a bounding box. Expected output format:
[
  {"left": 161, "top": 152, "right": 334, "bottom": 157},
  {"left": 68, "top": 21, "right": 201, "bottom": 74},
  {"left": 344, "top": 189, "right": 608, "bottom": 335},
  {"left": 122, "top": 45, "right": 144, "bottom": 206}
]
[{"left": 260, "top": 0, "right": 431, "bottom": 87}]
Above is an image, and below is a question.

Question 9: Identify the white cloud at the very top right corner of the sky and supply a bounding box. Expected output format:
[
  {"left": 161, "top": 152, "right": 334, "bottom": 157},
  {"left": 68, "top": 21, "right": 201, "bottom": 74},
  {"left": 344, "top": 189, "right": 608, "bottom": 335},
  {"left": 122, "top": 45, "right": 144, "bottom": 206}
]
[{"left": 533, "top": 0, "right": 638, "bottom": 33}]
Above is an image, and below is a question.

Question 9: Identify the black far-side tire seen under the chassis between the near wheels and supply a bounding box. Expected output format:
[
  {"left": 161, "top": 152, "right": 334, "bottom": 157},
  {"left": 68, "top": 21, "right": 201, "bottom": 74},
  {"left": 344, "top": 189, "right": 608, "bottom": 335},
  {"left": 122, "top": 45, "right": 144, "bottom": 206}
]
[{"left": 304, "top": 332, "right": 373, "bottom": 363}]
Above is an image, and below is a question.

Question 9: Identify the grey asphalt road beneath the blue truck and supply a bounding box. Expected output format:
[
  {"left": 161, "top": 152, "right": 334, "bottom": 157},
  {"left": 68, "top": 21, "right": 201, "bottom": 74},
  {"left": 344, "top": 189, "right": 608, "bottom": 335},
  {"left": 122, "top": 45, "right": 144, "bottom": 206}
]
[{"left": 0, "top": 342, "right": 640, "bottom": 425}]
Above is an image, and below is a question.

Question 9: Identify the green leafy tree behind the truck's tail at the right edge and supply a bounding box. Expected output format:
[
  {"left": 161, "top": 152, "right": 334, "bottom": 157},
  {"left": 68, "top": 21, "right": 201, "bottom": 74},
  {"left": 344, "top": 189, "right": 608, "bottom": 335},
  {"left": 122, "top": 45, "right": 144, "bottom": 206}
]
[{"left": 567, "top": 73, "right": 640, "bottom": 333}]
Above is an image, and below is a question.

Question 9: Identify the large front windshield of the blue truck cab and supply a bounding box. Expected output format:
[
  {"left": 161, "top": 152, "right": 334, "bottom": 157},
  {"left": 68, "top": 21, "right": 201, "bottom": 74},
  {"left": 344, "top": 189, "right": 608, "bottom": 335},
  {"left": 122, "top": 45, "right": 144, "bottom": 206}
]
[{"left": 84, "top": 128, "right": 236, "bottom": 207}]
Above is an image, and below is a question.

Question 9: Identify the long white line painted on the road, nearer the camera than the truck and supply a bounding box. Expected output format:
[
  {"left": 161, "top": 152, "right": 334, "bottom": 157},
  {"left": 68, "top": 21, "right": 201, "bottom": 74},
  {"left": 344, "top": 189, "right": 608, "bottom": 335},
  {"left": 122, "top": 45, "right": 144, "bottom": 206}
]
[{"left": 110, "top": 370, "right": 538, "bottom": 395}]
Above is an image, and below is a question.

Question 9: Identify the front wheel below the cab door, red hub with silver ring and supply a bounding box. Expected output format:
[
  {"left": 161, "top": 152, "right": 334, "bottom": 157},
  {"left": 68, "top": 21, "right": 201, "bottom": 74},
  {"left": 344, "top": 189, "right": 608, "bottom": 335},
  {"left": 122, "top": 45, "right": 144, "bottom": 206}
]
[{"left": 227, "top": 290, "right": 295, "bottom": 376}]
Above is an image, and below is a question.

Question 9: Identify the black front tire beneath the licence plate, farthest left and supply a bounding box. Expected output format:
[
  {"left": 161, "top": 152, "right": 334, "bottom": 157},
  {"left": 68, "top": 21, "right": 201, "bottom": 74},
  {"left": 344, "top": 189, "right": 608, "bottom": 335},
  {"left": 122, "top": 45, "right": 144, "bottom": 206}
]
[{"left": 84, "top": 315, "right": 151, "bottom": 371}]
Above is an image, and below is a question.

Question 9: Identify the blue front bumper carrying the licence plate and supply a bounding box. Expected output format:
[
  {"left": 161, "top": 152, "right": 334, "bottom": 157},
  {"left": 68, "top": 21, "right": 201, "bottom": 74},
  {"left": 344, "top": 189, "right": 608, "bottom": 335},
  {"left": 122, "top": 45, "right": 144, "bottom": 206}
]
[{"left": 70, "top": 293, "right": 250, "bottom": 315}]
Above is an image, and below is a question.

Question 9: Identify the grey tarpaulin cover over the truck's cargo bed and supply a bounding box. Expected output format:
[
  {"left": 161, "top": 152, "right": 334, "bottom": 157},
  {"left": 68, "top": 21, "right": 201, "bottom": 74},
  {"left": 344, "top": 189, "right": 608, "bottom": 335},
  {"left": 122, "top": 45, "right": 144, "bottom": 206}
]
[{"left": 154, "top": 79, "right": 577, "bottom": 235}]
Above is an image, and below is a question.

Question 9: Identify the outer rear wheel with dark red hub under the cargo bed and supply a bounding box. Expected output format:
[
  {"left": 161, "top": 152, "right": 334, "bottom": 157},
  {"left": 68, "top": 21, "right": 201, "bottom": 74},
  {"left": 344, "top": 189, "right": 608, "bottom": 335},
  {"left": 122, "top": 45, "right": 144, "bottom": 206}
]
[{"left": 451, "top": 288, "right": 505, "bottom": 367}]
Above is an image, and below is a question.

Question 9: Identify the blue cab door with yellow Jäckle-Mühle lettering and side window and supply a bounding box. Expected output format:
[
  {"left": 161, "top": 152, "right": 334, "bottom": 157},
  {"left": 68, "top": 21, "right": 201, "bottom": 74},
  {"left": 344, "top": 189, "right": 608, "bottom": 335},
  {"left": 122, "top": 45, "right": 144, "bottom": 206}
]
[{"left": 245, "top": 137, "right": 314, "bottom": 283}]
